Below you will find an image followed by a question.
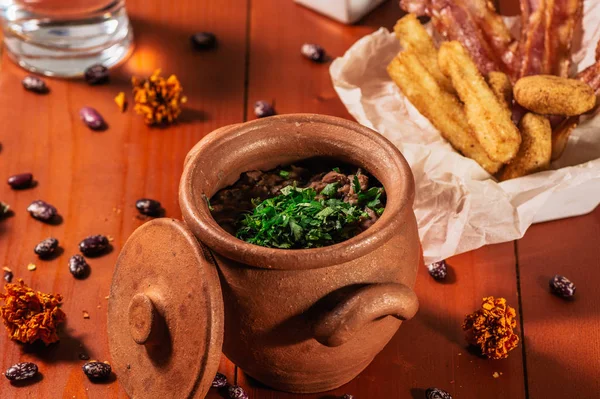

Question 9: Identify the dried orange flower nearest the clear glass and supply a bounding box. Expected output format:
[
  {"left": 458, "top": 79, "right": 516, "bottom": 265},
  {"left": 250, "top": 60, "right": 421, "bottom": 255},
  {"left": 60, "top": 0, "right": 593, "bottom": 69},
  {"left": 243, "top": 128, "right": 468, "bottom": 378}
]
[{"left": 131, "top": 69, "right": 187, "bottom": 125}]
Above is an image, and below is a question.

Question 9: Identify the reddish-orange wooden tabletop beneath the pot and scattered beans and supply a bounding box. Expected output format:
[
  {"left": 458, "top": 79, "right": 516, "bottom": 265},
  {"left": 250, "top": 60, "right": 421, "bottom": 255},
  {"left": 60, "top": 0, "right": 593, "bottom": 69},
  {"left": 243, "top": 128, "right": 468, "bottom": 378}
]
[{"left": 0, "top": 0, "right": 600, "bottom": 399}]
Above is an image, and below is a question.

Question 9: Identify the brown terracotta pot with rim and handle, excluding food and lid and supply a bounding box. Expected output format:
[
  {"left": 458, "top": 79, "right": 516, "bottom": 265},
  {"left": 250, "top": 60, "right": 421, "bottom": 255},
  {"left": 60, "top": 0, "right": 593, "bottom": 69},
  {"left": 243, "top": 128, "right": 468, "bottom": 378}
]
[{"left": 177, "top": 114, "right": 420, "bottom": 392}]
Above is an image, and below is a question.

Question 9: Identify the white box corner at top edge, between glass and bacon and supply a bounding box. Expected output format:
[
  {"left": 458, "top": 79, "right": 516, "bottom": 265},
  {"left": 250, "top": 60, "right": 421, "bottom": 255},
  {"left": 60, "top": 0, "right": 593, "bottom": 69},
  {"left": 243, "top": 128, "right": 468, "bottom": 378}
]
[{"left": 294, "top": 0, "right": 385, "bottom": 24}]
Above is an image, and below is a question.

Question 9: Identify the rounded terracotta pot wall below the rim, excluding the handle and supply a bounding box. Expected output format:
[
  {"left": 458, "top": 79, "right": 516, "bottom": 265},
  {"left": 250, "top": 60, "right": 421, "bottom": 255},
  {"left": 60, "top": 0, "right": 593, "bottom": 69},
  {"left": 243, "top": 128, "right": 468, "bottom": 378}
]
[{"left": 215, "top": 223, "right": 420, "bottom": 393}]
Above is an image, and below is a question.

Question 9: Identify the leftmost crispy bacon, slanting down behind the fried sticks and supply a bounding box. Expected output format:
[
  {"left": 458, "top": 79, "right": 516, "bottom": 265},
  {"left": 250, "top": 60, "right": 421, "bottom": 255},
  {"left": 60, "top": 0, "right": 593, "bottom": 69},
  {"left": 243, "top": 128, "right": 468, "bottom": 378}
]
[{"left": 400, "top": 0, "right": 518, "bottom": 77}]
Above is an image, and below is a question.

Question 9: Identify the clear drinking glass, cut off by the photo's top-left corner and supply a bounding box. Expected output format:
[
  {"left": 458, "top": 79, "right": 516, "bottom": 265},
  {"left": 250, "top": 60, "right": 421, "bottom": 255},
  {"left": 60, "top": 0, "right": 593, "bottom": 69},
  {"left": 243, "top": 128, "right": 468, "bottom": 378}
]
[{"left": 0, "top": 0, "right": 133, "bottom": 77}]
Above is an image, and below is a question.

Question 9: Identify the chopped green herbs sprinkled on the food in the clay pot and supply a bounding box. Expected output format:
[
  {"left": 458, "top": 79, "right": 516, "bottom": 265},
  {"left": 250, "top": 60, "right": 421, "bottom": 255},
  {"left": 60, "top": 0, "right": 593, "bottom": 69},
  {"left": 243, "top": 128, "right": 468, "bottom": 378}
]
[{"left": 236, "top": 183, "right": 368, "bottom": 248}]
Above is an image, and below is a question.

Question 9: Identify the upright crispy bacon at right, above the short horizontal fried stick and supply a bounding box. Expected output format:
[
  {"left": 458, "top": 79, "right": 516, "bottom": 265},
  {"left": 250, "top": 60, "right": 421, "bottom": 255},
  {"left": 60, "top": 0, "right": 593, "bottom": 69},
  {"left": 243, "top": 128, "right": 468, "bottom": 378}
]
[{"left": 518, "top": 0, "right": 583, "bottom": 77}]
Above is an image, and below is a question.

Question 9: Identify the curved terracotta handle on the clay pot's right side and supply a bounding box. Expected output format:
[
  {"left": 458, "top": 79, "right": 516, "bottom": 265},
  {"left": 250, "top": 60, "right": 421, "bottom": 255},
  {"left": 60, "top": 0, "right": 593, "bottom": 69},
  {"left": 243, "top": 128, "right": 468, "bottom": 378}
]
[{"left": 313, "top": 283, "right": 419, "bottom": 347}]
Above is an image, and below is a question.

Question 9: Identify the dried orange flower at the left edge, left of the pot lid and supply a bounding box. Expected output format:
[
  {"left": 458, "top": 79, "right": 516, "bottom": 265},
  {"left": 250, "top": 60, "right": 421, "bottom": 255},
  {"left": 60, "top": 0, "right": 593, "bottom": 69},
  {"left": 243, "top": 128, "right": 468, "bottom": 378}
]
[{"left": 0, "top": 279, "right": 66, "bottom": 345}]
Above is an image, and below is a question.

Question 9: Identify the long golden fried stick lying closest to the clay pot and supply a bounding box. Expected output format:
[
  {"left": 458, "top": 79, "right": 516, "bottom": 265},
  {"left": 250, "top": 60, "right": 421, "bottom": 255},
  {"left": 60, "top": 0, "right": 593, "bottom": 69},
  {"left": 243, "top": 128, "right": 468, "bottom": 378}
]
[{"left": 387, "top": 50, "right": 502, "bottom": 174}]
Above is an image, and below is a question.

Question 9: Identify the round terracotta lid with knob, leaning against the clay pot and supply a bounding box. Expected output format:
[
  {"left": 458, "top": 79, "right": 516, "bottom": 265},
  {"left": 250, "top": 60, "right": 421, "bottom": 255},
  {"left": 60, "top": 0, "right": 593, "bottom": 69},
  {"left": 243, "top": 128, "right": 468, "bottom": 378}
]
[{"left": 108, "top": 219, "right": 224, "bottom": 399}]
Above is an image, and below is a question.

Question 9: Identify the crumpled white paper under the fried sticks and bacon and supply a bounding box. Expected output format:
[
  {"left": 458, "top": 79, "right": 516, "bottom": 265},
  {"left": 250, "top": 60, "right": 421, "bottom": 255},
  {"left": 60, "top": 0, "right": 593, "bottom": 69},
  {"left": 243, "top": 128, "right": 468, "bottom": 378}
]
[{"left": 330, "top": 0, "right": 600, "bottom": 264}]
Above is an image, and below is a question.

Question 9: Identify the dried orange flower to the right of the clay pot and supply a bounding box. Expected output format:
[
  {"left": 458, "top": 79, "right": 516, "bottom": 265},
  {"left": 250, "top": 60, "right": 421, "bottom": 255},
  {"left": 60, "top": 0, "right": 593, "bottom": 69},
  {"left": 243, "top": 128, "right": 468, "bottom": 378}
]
[{"left": 462, "top": 296, "right": 519, "bottom": 359}]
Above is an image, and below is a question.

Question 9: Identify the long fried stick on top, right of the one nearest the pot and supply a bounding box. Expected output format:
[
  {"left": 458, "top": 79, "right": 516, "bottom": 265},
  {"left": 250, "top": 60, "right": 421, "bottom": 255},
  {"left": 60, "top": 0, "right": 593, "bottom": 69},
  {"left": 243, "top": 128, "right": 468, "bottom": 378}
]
[{"left": 438, "top": 41, "right": 521, "bottom": 163}]
